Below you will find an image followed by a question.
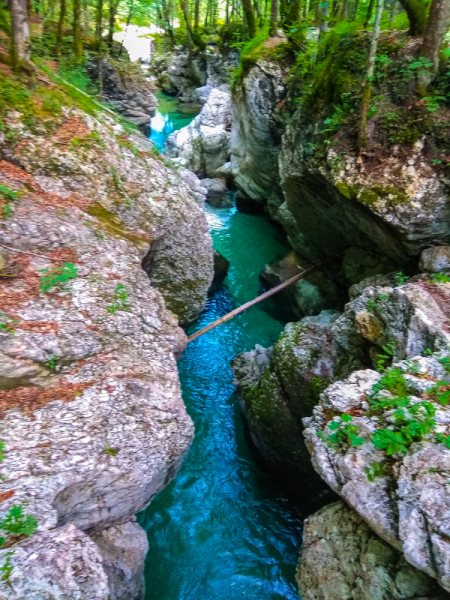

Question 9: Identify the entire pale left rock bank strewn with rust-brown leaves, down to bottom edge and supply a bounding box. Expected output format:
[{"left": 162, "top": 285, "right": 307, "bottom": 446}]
[{"left": 0, "top": 83, "right": 213, "bottom": 600}]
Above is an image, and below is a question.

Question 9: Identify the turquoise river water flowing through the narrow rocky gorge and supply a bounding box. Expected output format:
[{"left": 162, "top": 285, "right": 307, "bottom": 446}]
[{"left": 138, "top": 91, "right": 303, "bottom": 600}]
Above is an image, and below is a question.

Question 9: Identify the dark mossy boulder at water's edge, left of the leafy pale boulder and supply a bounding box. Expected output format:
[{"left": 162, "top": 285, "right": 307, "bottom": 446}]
[{"left": 232, "top": 311, "right": 339, "bottom": 507}]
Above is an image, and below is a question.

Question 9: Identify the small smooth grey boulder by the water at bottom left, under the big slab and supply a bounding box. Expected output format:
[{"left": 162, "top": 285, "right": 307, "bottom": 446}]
[{"left": 92, "top": 521, "right": 148, "bottom": 600}]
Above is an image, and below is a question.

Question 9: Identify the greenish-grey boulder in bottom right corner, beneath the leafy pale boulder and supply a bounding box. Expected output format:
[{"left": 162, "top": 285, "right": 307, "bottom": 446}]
[{"left": 297, "top": 502, "right": 450, "bottom": 600}]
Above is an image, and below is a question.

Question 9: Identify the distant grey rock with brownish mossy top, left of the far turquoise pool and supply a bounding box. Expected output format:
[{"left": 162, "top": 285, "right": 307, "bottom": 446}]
[{"left": 90, "top": 57, "right": 158, "bottom": 134}]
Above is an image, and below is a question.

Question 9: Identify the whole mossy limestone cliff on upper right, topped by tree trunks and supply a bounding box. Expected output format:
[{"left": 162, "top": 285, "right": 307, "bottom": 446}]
[{"left": 231, "top": 32, "right": 450, "bottom": 287}]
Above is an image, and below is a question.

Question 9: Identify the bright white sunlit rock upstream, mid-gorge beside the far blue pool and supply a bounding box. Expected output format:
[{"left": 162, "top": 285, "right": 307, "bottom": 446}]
[{"left": 166, "top": 89, "right": 232, "bottom": 178}]
